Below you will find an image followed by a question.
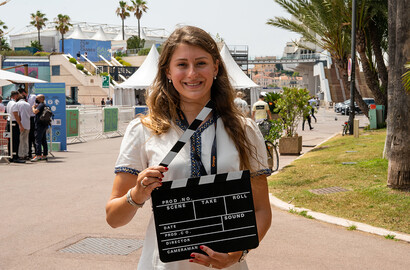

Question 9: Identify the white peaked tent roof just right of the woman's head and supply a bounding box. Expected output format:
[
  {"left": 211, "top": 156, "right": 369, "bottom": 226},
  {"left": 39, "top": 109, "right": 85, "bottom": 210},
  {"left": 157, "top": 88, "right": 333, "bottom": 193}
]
[{"left": 221, "top": 44, "right": 260, "bottom": 89}]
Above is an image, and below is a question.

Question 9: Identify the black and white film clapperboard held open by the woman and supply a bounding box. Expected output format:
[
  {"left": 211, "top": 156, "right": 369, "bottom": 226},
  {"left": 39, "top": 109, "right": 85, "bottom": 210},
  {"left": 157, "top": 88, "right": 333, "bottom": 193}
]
[{"left": 151, "top": 102, "right": 259, "bottom": 262}]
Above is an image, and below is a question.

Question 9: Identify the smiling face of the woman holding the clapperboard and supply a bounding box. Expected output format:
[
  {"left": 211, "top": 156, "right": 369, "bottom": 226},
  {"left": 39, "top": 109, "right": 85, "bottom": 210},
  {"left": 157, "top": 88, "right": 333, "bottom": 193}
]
[{"left": 167, "top": 43, "right": 219, "bottom": 104}]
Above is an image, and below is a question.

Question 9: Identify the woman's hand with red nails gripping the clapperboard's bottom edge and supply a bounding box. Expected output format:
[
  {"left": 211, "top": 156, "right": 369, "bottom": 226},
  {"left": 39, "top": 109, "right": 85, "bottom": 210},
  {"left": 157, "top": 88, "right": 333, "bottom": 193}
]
[{"left": 189, "top": 246, "right": 242, "bottom": 269}]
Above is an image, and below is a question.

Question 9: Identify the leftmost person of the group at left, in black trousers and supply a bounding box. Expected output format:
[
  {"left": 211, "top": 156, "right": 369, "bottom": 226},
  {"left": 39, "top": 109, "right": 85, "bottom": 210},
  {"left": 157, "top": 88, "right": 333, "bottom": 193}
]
[{"left": 6, "top": 90, "right": 25, "bottom": 163}]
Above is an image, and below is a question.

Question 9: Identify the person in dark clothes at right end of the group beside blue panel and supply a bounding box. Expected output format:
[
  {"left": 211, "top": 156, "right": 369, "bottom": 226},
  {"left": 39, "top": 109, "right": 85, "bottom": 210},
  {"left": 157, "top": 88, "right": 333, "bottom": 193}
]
[{"left": 31, "top": 94, "right": 48, "bottom": 162}]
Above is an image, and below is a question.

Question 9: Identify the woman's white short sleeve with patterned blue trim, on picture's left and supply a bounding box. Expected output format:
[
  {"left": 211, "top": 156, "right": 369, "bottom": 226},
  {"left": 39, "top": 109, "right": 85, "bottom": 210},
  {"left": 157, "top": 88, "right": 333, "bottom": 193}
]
[{"left": 115, "top": 118, "right": 148, "bottom": 175}]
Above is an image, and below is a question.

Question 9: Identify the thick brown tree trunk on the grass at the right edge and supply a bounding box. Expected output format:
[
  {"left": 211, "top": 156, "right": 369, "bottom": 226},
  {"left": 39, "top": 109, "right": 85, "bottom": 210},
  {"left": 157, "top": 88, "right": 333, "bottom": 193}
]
[{"left": 386, "top": 0, "right": 410, "bottom": 189}]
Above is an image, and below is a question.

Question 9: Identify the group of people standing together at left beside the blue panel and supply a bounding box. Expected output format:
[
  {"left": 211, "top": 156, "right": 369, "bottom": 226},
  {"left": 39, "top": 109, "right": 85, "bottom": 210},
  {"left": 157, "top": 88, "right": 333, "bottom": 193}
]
[{"left": 0, "top": 88, "right": 50, "bottom": 163}]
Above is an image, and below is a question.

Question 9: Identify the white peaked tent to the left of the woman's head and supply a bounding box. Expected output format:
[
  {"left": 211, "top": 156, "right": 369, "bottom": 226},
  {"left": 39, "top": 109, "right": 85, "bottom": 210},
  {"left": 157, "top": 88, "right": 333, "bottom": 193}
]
[{"left": 114, "top": 45, "right": 159, "bottom": 105}]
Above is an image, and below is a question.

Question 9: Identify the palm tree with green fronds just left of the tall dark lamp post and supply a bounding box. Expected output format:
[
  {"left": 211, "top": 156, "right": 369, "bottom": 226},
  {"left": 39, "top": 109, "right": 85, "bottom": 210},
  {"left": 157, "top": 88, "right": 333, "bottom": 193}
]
[{"left": 267, "top": 0, "right": 374, "bottom": 116}]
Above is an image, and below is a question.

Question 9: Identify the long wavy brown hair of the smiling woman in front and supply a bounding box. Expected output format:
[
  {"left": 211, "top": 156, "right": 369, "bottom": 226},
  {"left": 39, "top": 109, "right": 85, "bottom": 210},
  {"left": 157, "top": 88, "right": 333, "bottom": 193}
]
[{"left": 141, "top": 26, "right": 256, "bottom": 170}]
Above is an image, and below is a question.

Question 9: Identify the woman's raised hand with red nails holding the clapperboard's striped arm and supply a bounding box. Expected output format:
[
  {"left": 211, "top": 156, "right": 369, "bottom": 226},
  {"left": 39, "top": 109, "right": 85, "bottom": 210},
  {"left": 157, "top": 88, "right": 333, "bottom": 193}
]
[{"left": 131, "top": 166, "right": 168, "bottom": 204}]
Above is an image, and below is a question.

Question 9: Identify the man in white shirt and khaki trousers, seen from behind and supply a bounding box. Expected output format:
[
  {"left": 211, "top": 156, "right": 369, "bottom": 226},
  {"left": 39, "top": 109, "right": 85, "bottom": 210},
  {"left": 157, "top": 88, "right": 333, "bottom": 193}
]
[{"left": 12, "top": 95, "right": 32, "bottom": 160}]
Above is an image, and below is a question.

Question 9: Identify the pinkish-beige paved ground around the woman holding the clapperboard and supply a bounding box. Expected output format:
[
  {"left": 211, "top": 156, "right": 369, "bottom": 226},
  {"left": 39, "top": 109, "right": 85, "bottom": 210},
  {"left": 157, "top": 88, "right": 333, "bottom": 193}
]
[{"left": 0, "top": 108, "right": 410, "bottom": 270}]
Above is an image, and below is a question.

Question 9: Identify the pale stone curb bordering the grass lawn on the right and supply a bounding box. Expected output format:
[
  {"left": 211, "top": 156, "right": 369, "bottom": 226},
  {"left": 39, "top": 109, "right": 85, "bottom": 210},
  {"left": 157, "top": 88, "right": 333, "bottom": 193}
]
[{"left": 269, "top": 132, "right": 410, "bottom": 243}]
